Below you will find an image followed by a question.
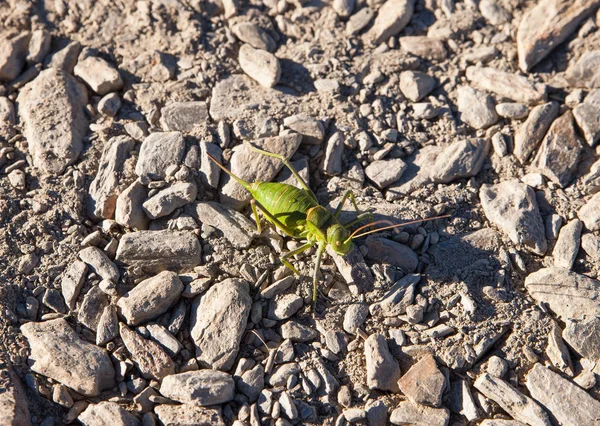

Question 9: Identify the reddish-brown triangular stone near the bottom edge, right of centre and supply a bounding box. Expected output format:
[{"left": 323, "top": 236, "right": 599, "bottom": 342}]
[{"left": 398, "top": 354, "right": 446, "bottom": 408}]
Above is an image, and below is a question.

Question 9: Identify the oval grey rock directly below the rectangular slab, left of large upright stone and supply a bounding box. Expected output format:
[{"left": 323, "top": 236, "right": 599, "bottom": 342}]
[{"left": 117, "top": 271, "right": 184, "bottom": 325}]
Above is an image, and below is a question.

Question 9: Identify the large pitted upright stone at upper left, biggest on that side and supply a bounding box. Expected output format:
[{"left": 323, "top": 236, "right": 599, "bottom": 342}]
[{"left": 17, "top": 68, "right": 88, "bottom": 175}]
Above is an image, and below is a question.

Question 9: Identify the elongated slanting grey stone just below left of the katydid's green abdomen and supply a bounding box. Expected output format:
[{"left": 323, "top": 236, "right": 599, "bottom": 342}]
[{"left": 185, "top": 201, "right": 257, "bottom": 249}]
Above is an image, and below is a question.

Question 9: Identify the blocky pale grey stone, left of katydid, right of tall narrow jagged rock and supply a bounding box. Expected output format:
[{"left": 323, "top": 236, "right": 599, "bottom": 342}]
[{"left": 135, "top": 132, "right": 185, "bottom": 180}]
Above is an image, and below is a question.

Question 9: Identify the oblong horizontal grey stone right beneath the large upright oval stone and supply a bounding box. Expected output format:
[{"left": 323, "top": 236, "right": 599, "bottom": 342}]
[{"left": 160, "top": 370, "right": 235, "bottom": 406}]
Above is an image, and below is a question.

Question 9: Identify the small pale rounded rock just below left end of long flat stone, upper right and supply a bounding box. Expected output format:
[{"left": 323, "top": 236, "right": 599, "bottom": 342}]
[{"left": 457, "top": 86, "right": 498, "bottom": 129}]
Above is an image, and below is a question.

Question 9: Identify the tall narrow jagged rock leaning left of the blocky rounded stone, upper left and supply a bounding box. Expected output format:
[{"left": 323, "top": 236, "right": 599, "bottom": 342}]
[{"left": 89, "top": 136, "right": 135, "bottom": 219}]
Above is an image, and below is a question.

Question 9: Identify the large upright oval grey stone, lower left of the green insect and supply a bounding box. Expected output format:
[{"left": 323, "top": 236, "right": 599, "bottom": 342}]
[{"left": 190, "top": 279, "right": 252, "bottom": 370}]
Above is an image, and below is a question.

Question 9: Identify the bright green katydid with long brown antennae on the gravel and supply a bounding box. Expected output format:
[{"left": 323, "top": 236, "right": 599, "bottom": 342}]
[{"left": 208, "top": 143, "right": 446, "bottom": 306}]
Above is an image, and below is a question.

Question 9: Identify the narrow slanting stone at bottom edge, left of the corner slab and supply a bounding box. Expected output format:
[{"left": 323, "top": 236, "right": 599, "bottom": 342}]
[{"left": 474, "top": 374, "right": 552, "bottom": 426}]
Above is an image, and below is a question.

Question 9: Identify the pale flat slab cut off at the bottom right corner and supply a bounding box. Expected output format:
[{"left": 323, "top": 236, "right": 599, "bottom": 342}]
[{"left": 525, "top": 364, "right": 600, "bottom": 426}]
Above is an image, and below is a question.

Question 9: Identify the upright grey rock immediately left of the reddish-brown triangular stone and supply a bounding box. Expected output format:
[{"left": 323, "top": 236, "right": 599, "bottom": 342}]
[{"left": 365, "top": 333, "right": 400, "bottom": 392}]
